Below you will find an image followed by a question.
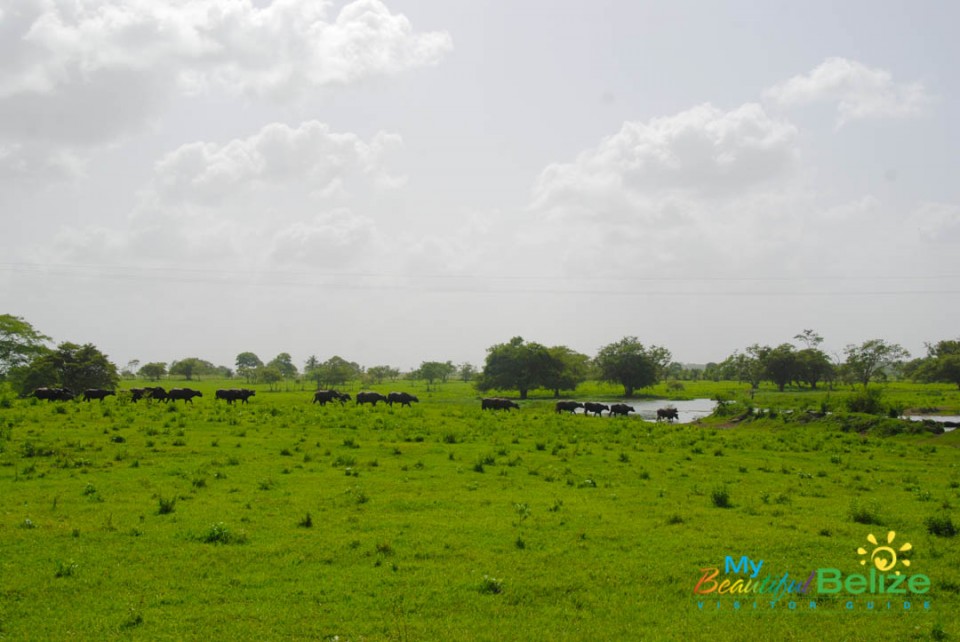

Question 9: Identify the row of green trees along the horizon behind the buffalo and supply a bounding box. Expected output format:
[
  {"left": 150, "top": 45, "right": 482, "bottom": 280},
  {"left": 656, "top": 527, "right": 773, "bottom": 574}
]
[{"left": 0, "top": 314, "right": 960, "bottom": 399}]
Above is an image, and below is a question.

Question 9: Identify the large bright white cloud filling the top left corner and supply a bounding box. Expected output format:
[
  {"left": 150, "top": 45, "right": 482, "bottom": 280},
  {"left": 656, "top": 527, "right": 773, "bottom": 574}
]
[{"left": 0, "top": 0, "right": 452, "bottom": 168}]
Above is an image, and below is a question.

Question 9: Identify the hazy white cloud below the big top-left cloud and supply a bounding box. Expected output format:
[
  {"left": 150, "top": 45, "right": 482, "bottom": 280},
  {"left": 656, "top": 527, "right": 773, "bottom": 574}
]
[{"left": 35, "top": 121, "right": 401, "bottom": 268}]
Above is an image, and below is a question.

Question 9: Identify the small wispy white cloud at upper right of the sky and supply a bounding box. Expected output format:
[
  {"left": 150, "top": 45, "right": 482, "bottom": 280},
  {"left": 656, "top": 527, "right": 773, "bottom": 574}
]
[{"left": 764, "top": 58, "right": 931, "bottom": 126}]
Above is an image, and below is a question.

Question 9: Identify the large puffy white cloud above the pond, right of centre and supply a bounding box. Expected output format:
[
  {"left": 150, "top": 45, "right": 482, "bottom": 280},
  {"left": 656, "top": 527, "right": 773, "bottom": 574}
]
[{"left": 532, "top": 103, "right": 798, "bottom": 225}]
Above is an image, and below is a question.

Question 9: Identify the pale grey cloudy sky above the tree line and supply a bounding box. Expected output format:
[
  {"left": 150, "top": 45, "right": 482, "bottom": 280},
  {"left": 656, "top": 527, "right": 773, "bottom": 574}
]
[{"left": 0, "top": 0, "right": 960, "bottom": 370}]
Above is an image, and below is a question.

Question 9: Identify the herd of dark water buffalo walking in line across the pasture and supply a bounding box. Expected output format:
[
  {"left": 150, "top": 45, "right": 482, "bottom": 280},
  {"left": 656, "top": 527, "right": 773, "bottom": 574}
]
[{"left": 33, "top": 386, "right": 679, "bottom": 421}]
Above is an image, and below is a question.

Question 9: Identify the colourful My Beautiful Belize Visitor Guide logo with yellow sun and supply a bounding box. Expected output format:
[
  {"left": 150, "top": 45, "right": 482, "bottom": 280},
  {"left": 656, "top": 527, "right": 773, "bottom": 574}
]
[{"left": 693, "top": 531, "right": 931, "bottom": 610}]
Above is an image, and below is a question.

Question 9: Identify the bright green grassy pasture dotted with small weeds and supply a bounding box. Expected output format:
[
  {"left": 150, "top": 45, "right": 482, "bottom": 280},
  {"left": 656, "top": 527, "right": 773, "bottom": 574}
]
[{"left": 0, "top": 382, "right": 960, "bottom": 641}]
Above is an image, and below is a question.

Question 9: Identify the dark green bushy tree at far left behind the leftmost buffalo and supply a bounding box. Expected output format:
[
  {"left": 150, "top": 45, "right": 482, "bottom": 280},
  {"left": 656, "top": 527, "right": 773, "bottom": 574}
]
[{"left": 11, "top": 342, "right": 120, "bottom": 395}]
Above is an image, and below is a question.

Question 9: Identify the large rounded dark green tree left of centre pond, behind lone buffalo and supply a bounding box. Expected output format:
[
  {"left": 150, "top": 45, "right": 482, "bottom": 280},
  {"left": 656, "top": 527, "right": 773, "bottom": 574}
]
[{"left": 475, "top": 337, "right": 555, "bottom": 399}]
